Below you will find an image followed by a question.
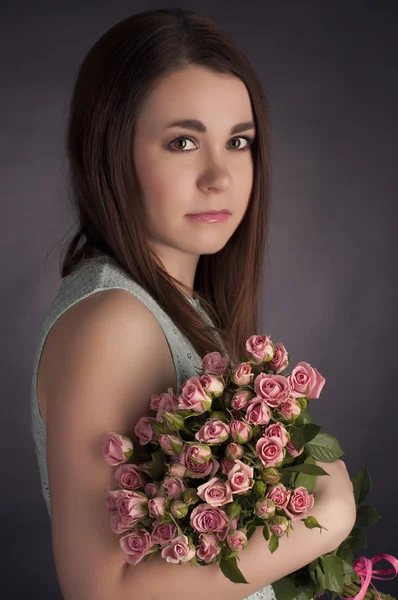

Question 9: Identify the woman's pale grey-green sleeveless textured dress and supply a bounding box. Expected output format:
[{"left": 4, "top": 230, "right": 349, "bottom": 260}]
[{"left": 31, "top": 256, "right": 276, "bottom": 600}]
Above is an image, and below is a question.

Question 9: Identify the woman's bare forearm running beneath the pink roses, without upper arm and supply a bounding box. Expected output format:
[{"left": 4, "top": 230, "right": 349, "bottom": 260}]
[{"left": 114, "top": 476, "right": 355, "bottom": 600}]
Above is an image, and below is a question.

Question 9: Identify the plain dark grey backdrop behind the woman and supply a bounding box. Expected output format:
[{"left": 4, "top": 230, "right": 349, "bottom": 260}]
[{"left": 0, "top": 0, "right": 398, "bottom": 600}]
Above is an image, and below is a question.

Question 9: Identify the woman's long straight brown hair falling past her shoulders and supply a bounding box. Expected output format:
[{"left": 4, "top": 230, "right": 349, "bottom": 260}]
[{"left": 57, "top": 8, "right": 270, "bottom": 363}]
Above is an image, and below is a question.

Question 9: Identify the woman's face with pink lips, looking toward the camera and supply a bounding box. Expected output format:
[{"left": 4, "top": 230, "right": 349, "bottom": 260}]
[{"left": 134, "top": 66, "right": 255, "bottom": 259}]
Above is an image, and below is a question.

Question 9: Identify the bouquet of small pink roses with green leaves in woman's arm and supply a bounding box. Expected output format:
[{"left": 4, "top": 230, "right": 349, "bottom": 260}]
[{"left": 102, "top": 335, "right": 398, "bottom": 600}]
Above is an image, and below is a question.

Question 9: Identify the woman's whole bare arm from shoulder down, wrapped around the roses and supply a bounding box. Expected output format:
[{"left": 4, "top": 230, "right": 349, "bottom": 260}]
[{"left": 46, "top": 290, "right": 353, "bottom": 600}]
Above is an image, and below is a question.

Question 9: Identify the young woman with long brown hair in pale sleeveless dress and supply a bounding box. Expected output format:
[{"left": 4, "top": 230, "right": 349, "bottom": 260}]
[{"left": 32, "top": 10, "right": 355, "bottom": 600}]
